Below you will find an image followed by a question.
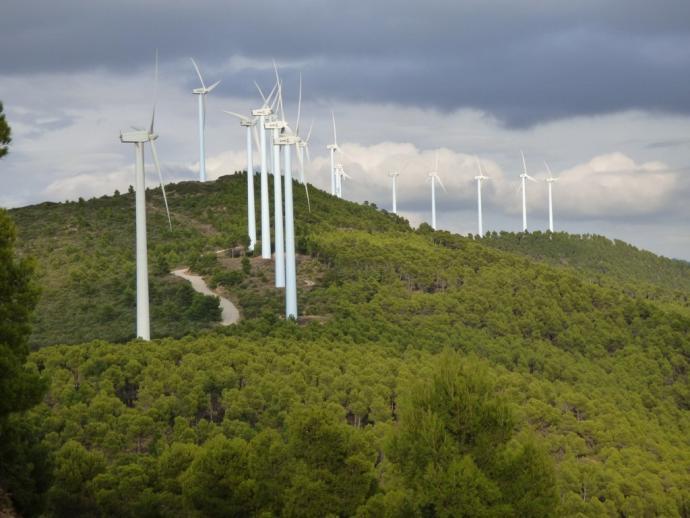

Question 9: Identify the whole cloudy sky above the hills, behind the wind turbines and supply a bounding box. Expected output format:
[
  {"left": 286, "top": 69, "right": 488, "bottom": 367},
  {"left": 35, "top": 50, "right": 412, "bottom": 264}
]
[{"left": 0, "top": 0, "right": 690, "bottom": 260}]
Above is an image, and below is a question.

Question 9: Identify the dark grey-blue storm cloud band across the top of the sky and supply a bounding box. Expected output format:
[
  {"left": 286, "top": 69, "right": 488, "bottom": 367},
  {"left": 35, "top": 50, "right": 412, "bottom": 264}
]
[{"left": 0, "top": 0, "right": 690, "bottom": 126}]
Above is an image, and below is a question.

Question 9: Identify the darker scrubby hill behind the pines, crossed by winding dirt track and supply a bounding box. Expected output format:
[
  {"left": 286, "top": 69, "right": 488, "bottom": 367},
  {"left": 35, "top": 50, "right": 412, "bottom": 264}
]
[{"left": 10, "top": 174, "right": 410, "bottom": 348}]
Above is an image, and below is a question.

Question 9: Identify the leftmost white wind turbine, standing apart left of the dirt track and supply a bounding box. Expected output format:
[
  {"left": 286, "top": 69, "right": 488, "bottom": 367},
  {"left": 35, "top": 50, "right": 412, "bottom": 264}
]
[{"left": 120, "top": 52, "right": 172, "bottom": 340}]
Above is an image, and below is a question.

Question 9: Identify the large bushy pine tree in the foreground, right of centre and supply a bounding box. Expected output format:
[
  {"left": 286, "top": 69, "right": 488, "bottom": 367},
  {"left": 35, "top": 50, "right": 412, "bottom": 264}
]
[{"left": 389, "top": 353, "right": 557, "bottom": 517}]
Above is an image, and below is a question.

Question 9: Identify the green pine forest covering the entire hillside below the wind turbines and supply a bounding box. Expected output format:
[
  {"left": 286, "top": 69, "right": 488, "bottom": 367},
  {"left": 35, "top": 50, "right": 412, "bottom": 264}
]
[{"left": 0, "top": 173, "right": 690, "bottom": 517}]
